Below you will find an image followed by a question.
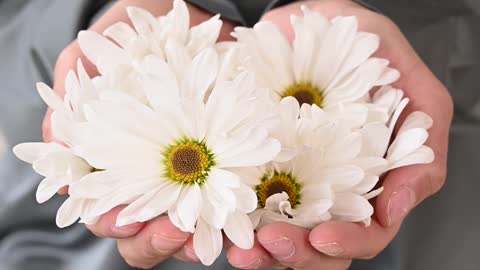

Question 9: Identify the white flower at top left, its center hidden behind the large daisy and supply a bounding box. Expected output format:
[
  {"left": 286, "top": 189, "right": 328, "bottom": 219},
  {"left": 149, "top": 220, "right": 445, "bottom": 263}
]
[{"left": 78, "top": 0, "right": 222, "bottom": 101}]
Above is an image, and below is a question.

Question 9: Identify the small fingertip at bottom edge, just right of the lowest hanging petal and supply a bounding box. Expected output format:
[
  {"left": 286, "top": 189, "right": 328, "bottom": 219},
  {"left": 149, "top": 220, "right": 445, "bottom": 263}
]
[{"left": 227, "top": 239, "right": 276, "bottom": 269}]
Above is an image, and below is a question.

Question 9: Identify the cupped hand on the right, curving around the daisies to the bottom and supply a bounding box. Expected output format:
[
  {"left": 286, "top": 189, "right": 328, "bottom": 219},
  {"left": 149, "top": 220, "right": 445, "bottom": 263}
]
[{"left": 227, "top": 0, "right": 453, "bottom": 270}]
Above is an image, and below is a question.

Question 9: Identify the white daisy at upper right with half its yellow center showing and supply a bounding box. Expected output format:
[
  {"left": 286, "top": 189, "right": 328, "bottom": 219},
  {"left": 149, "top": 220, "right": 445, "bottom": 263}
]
[{"left": 233, "top": 7, "right": 399, "bottom": 114}]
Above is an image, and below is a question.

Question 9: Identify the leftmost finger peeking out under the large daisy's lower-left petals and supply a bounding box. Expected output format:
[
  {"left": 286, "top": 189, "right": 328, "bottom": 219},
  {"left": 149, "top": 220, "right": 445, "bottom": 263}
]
[{"left": 87, "top": 206, "right": 144, "bottom": 239}]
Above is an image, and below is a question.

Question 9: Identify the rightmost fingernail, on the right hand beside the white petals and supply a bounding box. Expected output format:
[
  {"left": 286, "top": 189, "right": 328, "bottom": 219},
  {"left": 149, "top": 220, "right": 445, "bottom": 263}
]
[{"left": 387, "top": 186, "right": 416, "bottom": 226}]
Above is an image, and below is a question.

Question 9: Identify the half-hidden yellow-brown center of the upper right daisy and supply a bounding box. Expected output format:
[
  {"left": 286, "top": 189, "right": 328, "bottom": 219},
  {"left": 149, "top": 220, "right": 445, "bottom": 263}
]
[{"left": 281, "top": 83, "right": 323, "bottom": 107}]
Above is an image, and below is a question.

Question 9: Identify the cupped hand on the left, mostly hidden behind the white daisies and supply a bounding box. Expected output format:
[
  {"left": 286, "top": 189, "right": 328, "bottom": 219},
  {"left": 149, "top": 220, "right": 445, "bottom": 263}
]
[{"left": 43, "top": 0, "right": 234, "bottom": 269}]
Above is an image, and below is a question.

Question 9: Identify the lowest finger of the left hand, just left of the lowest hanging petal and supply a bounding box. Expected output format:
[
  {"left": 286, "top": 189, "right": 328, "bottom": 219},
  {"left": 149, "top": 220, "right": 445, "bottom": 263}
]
[{"left": 118, "top": 216, "right": 193, "bottom": 269}]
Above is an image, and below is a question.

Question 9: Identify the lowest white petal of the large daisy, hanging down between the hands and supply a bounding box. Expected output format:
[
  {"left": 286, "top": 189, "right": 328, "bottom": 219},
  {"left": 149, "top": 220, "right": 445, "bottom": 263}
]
[{"left": 193, "top": 219, "right": 223, "bottom": 266}]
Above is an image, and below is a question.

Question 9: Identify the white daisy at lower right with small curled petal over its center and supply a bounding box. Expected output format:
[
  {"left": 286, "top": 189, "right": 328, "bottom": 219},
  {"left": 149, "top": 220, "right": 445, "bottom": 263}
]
[{"left": 235, "top": 97, "right": 387, "bottom": 228}]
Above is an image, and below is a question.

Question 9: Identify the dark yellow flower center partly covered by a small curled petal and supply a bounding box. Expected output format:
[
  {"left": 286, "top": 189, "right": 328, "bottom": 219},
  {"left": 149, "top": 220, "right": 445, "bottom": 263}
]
[{"left": 256, "top": 171, "right": 302, "bottom": 208}]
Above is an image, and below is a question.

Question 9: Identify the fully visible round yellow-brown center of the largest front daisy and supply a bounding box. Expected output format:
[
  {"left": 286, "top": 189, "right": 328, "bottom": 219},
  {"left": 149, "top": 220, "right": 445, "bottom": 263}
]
[{"left": 163, "top": 139, "right": 215, "bottom": 184}]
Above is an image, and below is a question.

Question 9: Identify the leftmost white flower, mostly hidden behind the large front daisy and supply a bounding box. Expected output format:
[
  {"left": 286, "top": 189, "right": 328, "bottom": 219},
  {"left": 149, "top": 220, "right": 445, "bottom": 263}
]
[{"left": 13, "top": 61, "right": 97, "bottom": 228}]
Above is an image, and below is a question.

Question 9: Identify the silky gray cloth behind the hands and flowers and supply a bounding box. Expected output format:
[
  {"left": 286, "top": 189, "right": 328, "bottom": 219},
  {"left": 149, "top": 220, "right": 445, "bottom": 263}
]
[{"left": 0, "top": 0, "right": 480, "bottom": 270}]
